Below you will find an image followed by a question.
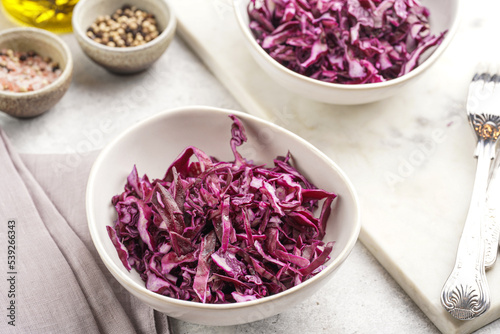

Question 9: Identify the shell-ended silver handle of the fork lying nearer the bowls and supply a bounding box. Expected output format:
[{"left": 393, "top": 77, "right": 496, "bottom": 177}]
[{"left": 441, "top": 139, "right": 495, "bottom": 320}]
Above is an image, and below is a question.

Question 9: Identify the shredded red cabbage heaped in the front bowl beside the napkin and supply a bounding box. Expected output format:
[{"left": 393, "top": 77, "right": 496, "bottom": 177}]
[{"left": 107, "top": 115, "right": 336, "bottom": 303}]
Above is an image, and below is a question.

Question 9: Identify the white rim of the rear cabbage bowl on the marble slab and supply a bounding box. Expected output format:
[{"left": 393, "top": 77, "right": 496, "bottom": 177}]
[{"left": 233, "top": 0, "right": 463, "bottom": 91}]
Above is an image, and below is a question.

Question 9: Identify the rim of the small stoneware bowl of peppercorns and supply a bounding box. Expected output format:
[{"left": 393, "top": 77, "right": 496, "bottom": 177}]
[{"left": 72, "top": 0, "right": 177, "bottom": 54}]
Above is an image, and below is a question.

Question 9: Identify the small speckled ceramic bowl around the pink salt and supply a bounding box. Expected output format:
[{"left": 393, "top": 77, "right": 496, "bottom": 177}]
[{"left": 0, "top": 28, "right": 73, "bottom": 118}]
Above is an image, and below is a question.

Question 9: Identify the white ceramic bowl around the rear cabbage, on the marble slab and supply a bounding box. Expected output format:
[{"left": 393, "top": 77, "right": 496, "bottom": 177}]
[{"left": 233, "top": 0, "right": 460, "bottom": 105}]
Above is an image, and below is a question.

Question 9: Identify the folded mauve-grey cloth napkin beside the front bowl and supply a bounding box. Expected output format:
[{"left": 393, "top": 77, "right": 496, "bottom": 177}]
[{"left": 0, "top": 129, "right": 169, "bottom": 334}]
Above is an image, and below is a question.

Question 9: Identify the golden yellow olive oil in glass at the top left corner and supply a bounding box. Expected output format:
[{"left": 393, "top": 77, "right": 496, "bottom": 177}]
[{"left": 2, "top": 0, "right": 78, "bottom": 33}]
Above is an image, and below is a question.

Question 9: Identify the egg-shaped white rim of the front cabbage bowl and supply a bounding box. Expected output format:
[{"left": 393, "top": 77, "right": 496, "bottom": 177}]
[{"left": 86, "top": 105, "right": 361, "bottom": 311}]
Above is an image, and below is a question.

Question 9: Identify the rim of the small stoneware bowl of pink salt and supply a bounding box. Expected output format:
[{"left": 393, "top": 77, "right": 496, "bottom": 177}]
[{"left": 0, "top": 27, "right": 73, "bottom": 97}]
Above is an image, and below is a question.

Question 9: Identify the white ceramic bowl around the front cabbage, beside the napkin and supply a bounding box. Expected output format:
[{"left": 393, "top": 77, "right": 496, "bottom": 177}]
[{"left": 86, "top": 107, "right": 360, "bottom": 325}]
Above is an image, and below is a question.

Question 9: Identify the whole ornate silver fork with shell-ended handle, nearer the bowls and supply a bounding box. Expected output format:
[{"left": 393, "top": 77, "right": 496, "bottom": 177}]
[{"left": 441, "top": 68, "right": 500, "bottom": 320}]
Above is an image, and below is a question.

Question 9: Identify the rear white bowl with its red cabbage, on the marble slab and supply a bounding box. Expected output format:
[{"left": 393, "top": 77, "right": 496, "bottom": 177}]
[{"left": 233, "top": 0, "right": 459, "bottom": 105}]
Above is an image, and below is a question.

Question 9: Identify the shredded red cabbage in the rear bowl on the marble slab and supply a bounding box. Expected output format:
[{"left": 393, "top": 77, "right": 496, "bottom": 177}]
[{"left": 248, "top": 0, "right": 446, "bottom": 84}]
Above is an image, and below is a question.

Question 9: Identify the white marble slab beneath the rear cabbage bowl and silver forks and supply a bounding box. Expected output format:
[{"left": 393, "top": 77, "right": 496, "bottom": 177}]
[{"left": 170, "top": 0, "right": 500, "bottom": 333}]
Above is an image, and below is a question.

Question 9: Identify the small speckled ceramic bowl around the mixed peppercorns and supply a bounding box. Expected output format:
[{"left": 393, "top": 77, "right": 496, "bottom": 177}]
[{"left": 72, "top": 0, "right": 177, "bottom": 74}]
